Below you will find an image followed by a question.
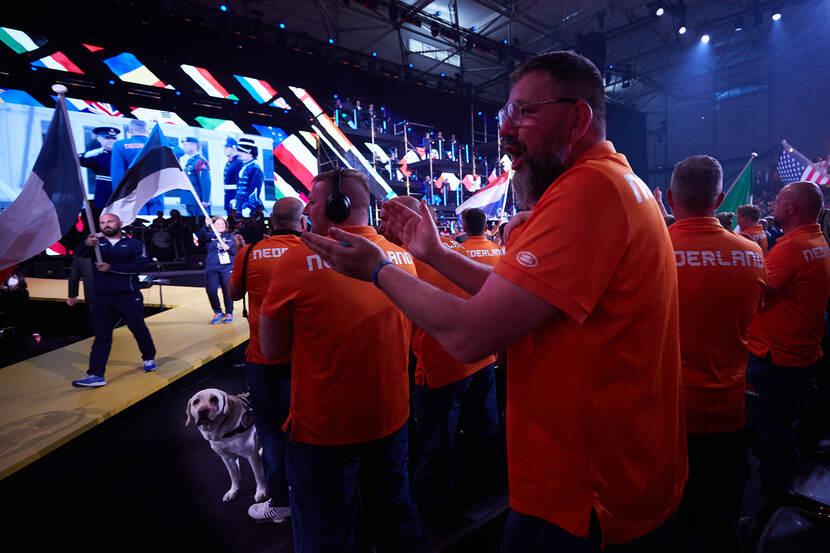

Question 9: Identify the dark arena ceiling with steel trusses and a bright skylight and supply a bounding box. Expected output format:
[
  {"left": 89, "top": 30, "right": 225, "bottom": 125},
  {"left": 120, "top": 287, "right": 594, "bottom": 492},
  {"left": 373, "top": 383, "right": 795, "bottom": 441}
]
[{"left": 189, "top": 0, "right": 820, "bottom": 110}]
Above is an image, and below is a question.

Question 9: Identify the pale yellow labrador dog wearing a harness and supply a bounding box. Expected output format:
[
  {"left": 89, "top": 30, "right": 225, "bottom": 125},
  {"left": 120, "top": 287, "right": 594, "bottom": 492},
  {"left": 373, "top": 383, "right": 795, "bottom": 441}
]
[{"left": 184, "top": 388, "right": 268, "bottom": 501}]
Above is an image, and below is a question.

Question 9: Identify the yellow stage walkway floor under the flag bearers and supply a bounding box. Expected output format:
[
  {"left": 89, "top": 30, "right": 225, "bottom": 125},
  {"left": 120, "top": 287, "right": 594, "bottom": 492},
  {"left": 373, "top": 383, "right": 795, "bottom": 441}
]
[{"left": 0, "top": 278, "right": 248, "bottom": 479}]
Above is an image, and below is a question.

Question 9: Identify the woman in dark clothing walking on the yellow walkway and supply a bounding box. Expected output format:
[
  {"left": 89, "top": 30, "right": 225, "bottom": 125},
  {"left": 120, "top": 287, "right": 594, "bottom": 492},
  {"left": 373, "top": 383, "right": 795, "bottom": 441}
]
[{"left": 199, "top": 213, "right": 236, "bottom": 324}]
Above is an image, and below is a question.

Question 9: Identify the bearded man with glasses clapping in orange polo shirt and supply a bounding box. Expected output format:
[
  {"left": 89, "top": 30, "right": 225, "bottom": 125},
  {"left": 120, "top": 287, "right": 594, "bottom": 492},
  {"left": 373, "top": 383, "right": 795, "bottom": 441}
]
[{"left": 303, "top": 52, "right": 688, "bottom": 553}]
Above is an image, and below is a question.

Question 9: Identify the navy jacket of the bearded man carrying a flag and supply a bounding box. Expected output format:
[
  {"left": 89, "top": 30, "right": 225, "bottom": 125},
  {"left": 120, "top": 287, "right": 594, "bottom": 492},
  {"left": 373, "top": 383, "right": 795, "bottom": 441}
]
[{"left": 79, "top": 236, "right": 149, "bottom": 296}]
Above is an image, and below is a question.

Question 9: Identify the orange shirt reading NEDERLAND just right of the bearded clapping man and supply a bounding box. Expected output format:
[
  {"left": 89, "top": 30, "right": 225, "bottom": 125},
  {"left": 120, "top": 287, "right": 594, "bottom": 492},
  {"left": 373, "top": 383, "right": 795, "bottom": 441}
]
[{"left": 669, "top": 217, "right": 767, "bottom": 433}]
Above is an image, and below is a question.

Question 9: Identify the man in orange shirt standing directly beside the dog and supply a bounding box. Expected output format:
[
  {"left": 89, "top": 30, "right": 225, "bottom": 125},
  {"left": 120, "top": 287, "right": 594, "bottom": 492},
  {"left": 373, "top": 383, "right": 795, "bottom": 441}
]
[{"left": 229, "top": 198, "right": 305, "bottom": 522}]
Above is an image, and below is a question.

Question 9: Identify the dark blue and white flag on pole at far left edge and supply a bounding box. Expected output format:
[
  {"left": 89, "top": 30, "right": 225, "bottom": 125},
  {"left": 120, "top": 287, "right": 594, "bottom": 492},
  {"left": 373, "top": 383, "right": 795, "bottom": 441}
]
[{"left": 0, "top": 98, "right": 84, "bottom": 269}]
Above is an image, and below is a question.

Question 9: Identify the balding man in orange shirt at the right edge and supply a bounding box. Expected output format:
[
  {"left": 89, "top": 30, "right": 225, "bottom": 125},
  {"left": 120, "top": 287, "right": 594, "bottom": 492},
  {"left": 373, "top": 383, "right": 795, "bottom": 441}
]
[{"left": 747, "top": 182, "right": 830, "bottom": 511}]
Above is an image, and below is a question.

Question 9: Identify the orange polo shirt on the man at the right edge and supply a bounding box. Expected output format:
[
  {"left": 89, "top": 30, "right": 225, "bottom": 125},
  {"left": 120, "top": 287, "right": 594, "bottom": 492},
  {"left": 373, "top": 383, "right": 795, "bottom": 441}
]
[{"left": 749, "top": 224, "right": 830, "bottom": 367}]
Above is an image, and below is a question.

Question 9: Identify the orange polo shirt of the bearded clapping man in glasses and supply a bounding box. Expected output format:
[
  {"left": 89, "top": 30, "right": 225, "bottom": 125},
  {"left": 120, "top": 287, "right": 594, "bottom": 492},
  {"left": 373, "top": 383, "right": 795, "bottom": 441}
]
[{"left": 494, "top": 142, "right": 688, "bottom": 544}]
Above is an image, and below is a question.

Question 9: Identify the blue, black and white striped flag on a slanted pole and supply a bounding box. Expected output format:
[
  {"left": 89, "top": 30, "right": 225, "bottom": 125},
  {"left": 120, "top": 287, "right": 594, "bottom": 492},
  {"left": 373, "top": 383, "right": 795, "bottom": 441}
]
[{"left": 103, "top": 124, "right": 200, "bottom": 225}]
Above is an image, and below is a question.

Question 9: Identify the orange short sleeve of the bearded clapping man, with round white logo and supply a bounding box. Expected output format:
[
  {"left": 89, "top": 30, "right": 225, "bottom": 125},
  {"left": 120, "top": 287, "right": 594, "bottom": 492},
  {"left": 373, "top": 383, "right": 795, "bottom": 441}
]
[{"left": 494, "top": 168, "right": 629, "bottom": 323}]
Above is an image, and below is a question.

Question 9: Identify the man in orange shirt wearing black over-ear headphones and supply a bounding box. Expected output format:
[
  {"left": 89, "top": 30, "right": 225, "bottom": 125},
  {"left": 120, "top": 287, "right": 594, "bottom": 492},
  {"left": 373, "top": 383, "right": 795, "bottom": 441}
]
[{"left": 259, "top": 170, "right": 420, "bottom": 553}]
